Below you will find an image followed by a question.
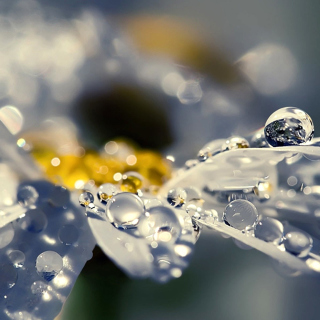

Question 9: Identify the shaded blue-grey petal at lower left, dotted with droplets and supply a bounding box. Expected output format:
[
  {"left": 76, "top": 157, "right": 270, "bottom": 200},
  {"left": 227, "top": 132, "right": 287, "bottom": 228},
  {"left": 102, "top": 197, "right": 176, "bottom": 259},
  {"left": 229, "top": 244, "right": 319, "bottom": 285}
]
[{"left": 0, "top": 181, "right": 95, "bottom": 320}]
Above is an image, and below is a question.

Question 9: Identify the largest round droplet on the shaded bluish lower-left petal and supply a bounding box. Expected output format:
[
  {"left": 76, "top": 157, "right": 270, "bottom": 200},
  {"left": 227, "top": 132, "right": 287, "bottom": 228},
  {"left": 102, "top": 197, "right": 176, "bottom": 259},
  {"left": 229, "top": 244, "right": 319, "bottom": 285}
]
[{"left": 36, "top": 251, "right": 63, "bottom": 281}]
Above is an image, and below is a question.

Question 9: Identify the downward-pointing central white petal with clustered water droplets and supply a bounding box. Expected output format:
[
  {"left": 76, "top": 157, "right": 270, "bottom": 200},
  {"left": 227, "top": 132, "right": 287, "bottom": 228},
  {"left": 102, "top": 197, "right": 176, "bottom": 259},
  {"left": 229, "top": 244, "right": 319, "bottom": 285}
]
[{"left": 79, "top": 180, "right": 196, "bottom": 282}]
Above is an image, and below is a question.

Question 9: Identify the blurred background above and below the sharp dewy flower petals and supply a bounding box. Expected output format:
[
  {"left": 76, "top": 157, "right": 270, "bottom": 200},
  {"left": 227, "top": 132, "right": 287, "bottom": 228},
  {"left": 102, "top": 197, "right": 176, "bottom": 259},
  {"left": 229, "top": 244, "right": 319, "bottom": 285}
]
[{"left": 0, "top": 0, "right": 320, "bottom": 320}]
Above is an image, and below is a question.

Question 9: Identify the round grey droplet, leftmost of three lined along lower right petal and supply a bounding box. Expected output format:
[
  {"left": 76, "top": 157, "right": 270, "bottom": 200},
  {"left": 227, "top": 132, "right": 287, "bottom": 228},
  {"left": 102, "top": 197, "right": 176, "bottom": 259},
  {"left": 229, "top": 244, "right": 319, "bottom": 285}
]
[{"left": 222, "top": 199, "right": 258, "bottom": 230}]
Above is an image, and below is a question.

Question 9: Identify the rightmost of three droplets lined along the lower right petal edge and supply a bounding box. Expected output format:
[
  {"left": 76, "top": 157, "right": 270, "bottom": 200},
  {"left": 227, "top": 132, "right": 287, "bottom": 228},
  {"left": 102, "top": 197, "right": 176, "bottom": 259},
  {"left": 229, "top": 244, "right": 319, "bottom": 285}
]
[{"left": 283, "top": 230, "right": 313, "bottom": 258}]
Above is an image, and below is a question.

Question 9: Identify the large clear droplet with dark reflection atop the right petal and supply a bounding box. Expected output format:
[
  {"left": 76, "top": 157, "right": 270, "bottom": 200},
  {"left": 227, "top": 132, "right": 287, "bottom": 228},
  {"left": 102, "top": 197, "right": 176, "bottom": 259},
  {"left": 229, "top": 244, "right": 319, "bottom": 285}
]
[{"left": 264, "top": 107, "right": 314, "bottom": 147}]
